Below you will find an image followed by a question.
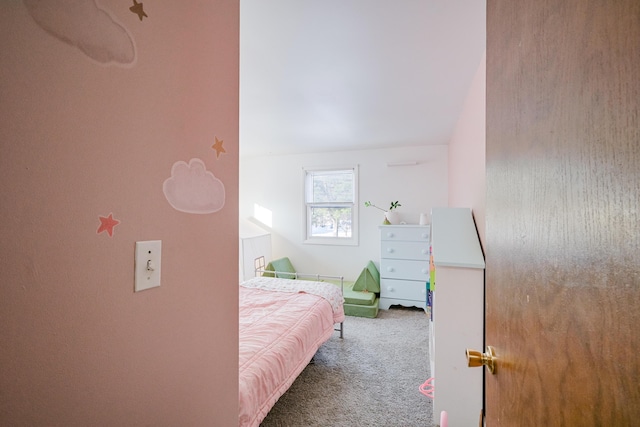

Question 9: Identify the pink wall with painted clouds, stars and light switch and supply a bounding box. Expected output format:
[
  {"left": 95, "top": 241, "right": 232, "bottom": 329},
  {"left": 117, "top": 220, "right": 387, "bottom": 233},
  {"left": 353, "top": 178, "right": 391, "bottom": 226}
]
[{"left": 0, "top": 0, "right": 239, "bottom": 426}]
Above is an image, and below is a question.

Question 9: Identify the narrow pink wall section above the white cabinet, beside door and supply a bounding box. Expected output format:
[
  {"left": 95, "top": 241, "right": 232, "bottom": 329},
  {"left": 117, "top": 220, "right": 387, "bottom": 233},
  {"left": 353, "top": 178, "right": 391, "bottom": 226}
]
[{"left": 449, "top": 55, "right": 486, "bottom": 246}]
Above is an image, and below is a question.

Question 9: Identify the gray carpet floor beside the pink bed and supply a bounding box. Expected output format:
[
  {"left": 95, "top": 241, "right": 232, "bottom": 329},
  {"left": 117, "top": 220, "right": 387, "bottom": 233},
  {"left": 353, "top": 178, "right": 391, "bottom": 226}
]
[{"left": 261, "top": 306, "right": 435, "bottom": 427}]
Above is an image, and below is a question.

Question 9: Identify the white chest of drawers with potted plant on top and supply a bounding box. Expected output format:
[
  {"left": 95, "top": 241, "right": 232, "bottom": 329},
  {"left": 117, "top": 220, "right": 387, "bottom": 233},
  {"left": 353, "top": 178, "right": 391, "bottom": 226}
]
[{"left": 380, "top": 225, "right": 430, "bottom": 310}]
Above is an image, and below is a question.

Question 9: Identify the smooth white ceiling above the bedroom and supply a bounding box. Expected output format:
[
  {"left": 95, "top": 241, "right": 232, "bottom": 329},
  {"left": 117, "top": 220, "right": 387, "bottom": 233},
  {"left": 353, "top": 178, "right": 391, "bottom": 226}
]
[{"left": 240, "top": 0, "right": 486, "bottom": 156}]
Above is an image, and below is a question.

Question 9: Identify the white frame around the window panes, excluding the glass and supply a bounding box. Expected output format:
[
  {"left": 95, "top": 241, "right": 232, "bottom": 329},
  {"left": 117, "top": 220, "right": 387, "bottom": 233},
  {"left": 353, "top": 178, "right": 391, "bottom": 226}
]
[{"left": 302, "top": 165, "right": 359, "bottom": 246}]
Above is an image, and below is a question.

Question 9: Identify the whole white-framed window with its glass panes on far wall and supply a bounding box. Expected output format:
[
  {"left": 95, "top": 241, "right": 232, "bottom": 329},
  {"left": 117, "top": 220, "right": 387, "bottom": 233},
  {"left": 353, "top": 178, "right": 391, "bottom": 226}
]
[{"left": 304, "top": 167, "right": 358, "bottom": 245}]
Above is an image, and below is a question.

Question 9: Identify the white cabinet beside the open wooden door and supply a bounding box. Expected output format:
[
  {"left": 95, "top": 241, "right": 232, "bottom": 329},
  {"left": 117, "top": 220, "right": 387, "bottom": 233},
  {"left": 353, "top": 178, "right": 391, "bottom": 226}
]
[{"left": 429, "top": 208, "right": 485, "bottom": 427}]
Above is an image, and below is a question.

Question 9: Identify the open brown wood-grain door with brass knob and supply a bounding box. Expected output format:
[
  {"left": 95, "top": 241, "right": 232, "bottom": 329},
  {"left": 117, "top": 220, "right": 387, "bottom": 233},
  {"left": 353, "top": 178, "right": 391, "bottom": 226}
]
[{"left": 485, "top": 0, "right": 640, "bottom": 427}]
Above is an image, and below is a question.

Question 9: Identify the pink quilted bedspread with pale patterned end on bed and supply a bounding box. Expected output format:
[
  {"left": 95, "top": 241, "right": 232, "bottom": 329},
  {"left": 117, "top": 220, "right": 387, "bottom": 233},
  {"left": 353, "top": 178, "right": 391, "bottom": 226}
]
[{"left": 239, "top": 277, "right": 344, "bottom": 427}]
